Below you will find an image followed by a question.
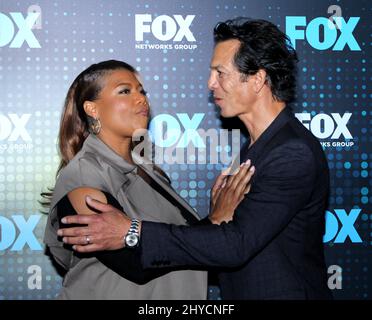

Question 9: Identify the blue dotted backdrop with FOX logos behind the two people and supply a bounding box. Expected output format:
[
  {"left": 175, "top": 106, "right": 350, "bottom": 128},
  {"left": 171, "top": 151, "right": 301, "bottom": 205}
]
[{"left": 0, "top": 0, "right": 372, "bottom": 300}]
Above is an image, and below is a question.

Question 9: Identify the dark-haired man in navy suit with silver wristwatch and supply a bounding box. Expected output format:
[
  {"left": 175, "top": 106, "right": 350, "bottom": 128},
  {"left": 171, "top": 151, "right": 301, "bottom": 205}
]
[{"left": 60, "top": 19, "right": 331, "bottom": 299}]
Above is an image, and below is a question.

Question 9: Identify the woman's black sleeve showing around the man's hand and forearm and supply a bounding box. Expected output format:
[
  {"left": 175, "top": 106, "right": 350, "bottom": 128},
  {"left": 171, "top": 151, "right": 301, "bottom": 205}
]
[{"left": 57, "top": 192, "right": 173, "bottom": 284}]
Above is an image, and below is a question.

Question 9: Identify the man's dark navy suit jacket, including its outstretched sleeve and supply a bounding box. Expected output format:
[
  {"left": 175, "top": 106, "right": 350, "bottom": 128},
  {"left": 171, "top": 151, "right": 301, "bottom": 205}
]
[{"left": 141, "top": 108, "right": 331, "bottom": 299}]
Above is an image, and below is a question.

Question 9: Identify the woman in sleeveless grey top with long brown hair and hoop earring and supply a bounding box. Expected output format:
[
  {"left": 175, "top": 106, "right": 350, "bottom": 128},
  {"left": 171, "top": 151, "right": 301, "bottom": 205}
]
[{"left": 44, "top": 60, "right": 253, "bottom": 299}]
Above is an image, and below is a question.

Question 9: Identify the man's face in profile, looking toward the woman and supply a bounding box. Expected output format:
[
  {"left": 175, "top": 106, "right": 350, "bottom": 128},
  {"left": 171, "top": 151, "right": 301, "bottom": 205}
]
[{"left": 208, "top": 39, "right": 254, "bottom": 118}]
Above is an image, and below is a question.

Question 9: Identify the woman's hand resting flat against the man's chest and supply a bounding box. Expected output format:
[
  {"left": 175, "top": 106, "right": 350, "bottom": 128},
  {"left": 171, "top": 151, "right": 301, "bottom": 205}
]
[{"left": 209, "top": 160, "right": 255, "bottom": 224}]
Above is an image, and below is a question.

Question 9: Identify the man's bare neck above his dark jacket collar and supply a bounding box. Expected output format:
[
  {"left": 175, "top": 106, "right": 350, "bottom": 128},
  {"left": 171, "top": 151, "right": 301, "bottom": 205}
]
[{"left": 239, "top": 99, "right": 285, "bottom": 146}]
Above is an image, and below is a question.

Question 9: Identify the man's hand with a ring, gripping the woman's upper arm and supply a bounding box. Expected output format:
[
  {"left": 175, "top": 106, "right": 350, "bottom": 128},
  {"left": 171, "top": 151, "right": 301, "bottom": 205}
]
[{"left": 58, "top": 196, "right": 131, "bottom": 252}]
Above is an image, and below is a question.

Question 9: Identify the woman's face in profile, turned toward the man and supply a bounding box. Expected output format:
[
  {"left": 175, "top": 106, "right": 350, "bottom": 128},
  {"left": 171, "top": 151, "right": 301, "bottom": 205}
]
[{"left": 86, "top": 69, "right": 150, "bottom": 138}]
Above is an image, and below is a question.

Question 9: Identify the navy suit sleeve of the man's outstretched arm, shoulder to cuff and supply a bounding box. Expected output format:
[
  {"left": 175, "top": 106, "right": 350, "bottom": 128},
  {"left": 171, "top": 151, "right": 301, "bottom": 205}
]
[{"left": 141, "top": 142, "right": 316, "bottom": 268}]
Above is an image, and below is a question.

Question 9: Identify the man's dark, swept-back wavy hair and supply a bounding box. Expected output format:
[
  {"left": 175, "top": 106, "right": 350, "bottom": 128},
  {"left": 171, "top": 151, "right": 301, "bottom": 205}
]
[{"left": 214, "top": 17, "right": 298, "bottom": 103}]
